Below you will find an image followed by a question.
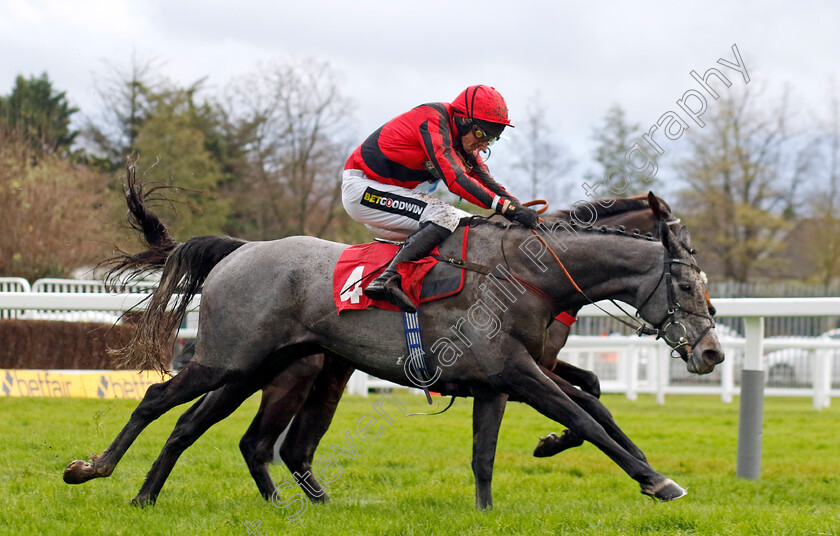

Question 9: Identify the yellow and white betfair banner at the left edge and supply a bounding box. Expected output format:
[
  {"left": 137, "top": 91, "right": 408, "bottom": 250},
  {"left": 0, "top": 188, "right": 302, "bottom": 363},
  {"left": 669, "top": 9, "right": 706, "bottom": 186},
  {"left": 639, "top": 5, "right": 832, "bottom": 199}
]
[{"left": 0, "top": 369, "right": 170, "bottom": 400}]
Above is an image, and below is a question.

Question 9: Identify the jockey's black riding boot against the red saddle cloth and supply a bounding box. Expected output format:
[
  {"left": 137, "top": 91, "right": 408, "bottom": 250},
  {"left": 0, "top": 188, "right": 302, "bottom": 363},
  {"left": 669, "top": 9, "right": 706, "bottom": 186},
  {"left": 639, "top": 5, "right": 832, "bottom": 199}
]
[{"left": 365, "top": 223, "right": 452, "bottom": 313}]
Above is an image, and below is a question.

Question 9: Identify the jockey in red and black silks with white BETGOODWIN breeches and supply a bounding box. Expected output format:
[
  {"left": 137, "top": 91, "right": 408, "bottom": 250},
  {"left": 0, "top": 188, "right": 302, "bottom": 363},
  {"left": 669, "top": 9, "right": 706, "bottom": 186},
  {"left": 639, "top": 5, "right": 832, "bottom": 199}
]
[{"left": 341, "top": 85, "right": 539, "bottom": 312}]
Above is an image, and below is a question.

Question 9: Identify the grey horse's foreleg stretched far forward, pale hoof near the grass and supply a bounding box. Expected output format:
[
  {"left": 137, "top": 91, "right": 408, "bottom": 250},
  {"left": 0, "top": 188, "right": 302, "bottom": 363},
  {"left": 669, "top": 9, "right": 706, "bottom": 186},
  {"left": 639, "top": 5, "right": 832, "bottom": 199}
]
[{"left": 502, "top": 356, "right": 685, "bottom": 501}]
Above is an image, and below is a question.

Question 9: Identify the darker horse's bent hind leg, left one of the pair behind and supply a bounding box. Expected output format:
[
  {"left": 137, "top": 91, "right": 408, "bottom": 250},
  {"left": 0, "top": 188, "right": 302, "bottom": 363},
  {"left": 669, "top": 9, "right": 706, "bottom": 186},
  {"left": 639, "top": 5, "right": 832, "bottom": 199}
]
[{"left": 239, "top": 354, "right": 324, "bottom": 500}]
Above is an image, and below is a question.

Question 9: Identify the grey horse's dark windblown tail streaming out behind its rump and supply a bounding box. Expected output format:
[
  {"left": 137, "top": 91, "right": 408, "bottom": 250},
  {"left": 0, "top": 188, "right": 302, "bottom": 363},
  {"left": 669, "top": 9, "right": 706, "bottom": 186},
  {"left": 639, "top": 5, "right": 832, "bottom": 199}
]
[{"left": 106, "top": 163, "right": 247, "bottom": 372}]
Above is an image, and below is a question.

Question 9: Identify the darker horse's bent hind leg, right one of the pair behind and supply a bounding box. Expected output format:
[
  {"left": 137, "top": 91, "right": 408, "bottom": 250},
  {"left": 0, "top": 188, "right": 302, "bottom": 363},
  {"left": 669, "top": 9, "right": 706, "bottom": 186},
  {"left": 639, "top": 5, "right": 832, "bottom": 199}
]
[{"left": 280, "top": 354, "right": 355, "bottom": 503}]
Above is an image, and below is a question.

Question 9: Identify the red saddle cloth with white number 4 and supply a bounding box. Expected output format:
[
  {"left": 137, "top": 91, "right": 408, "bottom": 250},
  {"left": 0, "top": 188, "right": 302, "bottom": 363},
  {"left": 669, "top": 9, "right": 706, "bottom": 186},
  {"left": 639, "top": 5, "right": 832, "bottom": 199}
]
[{"left": 333, "top": 242, "right": 438, "bottom": 314}]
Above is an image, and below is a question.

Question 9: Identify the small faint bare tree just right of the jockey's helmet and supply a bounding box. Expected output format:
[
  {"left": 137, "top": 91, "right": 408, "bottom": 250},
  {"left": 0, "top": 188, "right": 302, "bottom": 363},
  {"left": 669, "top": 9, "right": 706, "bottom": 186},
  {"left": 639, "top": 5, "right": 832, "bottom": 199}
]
[{"left": 513, "top": 94, "right": 575, "bottom": 202}]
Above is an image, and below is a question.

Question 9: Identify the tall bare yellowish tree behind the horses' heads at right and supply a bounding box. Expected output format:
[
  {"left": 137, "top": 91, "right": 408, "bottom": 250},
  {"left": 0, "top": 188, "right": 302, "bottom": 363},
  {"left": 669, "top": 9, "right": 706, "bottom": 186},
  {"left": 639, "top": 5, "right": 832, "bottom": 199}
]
[{"left": 677, "top": 89, "right": 808, "bottom": 282}]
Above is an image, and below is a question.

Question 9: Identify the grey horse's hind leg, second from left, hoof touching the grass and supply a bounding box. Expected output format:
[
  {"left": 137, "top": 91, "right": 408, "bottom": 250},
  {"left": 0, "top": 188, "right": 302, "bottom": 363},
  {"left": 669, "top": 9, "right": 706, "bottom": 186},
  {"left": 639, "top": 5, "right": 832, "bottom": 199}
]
[{"left": 131, "top": 372, "right": 264, "bottom": 506}]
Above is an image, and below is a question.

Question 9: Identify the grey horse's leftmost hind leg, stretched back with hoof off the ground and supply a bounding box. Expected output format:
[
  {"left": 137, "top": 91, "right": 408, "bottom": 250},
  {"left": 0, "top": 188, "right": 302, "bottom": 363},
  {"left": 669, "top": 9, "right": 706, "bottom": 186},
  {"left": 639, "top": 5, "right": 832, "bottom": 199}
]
[{"left": 64, "top": 363, "right": 230, "bottom": 484}]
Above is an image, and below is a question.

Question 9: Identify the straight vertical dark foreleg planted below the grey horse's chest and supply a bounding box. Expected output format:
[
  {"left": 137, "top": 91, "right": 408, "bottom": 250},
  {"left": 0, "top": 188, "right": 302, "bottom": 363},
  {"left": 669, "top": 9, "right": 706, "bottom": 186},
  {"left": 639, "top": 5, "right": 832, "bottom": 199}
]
[{"left": 472, "top": 391, "right": 508, "bottom": 510}]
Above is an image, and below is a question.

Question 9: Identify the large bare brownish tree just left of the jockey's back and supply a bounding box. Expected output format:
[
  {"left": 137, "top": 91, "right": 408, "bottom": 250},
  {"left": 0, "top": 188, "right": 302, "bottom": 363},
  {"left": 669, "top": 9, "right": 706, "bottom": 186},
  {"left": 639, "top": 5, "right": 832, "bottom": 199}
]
[{"left": 225, "top": 61, "right": 351, "bottom": 239}]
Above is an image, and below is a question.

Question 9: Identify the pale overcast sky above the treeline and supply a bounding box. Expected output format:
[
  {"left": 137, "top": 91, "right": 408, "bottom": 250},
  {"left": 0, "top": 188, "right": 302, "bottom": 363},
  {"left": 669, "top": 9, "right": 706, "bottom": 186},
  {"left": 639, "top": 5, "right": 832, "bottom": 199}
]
[{"left": 0, "top": 0, "right": 840, "bottom": 199}]
